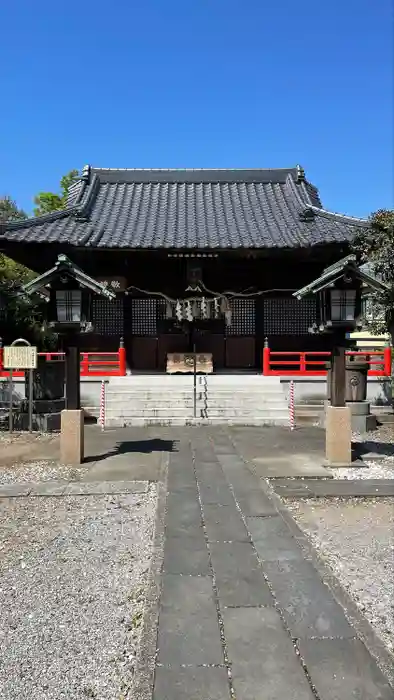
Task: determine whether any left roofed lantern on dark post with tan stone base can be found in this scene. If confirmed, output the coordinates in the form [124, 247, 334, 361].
[23, 255, 116, 463]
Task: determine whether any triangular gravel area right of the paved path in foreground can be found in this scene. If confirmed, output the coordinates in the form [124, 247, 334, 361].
[286, 498, 394, 663]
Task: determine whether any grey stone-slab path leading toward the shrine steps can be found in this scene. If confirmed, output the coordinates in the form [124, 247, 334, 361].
[153, 431, 394, 700]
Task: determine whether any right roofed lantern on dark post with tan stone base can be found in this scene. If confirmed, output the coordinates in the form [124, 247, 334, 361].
[293, 255, 390, 466]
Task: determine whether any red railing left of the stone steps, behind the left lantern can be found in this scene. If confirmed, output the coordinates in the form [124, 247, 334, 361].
[0, 345, 126, 377]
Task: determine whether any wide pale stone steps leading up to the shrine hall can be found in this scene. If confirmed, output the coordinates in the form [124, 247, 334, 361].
[101, 374, 289, 427]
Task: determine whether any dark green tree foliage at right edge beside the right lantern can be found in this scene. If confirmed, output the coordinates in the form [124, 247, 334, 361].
[354, 209, 394, 343]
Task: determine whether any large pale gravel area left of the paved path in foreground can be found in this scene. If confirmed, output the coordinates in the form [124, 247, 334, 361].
[0, 486, 156, 700]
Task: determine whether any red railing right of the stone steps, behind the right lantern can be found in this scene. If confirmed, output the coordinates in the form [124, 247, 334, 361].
[263, 347, 392, 377]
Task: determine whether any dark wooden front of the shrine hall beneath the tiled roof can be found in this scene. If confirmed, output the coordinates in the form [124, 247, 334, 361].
[63, 248, 338, 371]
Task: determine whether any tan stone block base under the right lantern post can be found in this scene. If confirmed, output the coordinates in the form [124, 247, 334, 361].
[326, 406, 352, 467]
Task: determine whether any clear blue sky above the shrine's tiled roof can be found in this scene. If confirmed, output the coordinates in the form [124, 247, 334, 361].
[0, 0, 393, 216]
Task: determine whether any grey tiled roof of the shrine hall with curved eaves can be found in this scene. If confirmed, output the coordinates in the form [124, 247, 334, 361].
[0, 166, 368, 250]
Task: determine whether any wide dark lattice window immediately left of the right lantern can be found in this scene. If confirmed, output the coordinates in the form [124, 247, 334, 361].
[264, 298, 316, 336]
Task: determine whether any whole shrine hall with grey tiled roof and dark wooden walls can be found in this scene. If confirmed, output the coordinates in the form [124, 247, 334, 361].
[0, 166, 368, 372]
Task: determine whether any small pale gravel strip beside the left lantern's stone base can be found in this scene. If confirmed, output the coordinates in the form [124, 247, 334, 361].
[0, 460, 87, 485]
